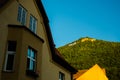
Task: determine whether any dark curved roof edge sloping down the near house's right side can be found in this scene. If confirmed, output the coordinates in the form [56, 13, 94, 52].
[36, 0, 77, 73]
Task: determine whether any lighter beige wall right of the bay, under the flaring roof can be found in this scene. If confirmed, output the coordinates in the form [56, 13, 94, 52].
[41, 43, 71, 80]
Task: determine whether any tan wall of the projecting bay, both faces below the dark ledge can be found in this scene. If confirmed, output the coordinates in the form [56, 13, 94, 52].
[2, 27, 43, 80]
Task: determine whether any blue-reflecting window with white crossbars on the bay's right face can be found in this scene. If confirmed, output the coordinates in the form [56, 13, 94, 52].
[27, 48, 36, 72]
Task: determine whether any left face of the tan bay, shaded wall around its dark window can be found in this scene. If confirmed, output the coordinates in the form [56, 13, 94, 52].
[2, 26, 22, 80]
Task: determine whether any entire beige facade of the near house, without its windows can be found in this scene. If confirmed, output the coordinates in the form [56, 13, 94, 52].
[0, 0, 77, 80]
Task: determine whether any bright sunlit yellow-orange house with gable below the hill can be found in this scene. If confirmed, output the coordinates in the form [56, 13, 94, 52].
[74, 64, 108, 80]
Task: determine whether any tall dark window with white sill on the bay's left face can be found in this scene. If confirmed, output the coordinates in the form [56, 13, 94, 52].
[4, 41, 16, 71]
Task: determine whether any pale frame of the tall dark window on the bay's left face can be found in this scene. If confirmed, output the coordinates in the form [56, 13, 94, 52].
[3, 41, 16, 72]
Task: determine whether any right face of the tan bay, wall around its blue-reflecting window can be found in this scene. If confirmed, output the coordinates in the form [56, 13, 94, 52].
[18, 27, 44, 80]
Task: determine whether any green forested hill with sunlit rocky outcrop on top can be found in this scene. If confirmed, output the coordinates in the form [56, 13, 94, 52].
[58, 37, 120, 80]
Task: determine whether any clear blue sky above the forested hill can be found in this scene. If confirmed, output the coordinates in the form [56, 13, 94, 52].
[42, 0, 120, 47]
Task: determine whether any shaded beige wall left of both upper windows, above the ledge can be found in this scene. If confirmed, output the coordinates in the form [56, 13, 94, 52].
[0, 0, 19, 25]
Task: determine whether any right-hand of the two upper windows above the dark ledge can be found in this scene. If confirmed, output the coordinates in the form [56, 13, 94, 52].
[29, 15, 37, 33]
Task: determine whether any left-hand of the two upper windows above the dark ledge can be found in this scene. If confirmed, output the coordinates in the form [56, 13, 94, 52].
[17, 5, 27, 25]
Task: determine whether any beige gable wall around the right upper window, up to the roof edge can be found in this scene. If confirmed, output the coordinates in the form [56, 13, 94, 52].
[18, 0, 44, 38]
